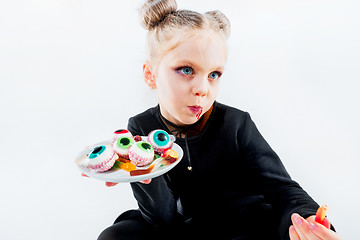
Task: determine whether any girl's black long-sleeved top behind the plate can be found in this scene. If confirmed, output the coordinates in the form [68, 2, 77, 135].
[104, 102, 318, 239]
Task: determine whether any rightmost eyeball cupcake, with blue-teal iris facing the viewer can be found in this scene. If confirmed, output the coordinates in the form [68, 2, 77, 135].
[148, 129, 175, 155]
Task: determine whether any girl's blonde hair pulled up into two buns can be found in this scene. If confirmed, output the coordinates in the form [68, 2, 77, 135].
[140, 0, 230, 61]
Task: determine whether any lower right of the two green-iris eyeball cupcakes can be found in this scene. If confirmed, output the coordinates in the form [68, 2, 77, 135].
[129, 141, 154, 167]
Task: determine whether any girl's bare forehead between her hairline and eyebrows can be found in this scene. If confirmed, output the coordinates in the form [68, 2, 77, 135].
[163, 31, 227, 68]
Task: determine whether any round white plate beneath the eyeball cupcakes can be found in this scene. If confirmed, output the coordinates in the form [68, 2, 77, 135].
[75, 137, 184, 183]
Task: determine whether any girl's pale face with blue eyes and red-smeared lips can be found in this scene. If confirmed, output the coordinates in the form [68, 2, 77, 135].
[144, 31, 226, 126]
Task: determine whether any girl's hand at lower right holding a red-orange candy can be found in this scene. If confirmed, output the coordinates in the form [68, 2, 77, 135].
[289, 213, 341, 240]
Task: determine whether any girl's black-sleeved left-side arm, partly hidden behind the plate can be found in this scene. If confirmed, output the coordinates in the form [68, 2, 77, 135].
[128, 118, 176, 226]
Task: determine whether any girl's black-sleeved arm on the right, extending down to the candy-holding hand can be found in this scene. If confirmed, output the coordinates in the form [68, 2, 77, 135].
[239, 113, 319, 239]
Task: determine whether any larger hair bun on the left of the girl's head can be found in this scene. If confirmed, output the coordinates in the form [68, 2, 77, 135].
[140, 0, 177, 30]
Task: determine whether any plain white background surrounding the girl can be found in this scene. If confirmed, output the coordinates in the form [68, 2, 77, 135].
[0, 0, 360, 240]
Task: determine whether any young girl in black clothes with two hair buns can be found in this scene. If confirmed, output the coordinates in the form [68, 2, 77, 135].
[99, 0, 340, 240]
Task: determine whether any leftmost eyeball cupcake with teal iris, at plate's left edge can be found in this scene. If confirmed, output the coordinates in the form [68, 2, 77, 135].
[87, 144, 118, 172]
